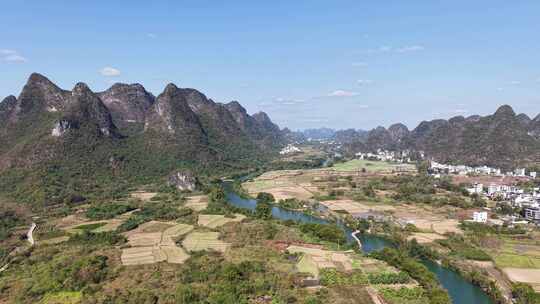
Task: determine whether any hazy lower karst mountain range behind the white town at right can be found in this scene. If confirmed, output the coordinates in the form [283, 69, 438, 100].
[336, 105, 540, 169]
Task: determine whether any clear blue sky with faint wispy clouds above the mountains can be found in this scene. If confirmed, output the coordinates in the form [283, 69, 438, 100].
[0, 0, 540, 129]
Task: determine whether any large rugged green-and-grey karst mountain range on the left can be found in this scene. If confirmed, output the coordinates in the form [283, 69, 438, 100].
[0, 74, 285, 203]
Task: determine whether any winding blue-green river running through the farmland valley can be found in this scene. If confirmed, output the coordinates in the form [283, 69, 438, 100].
[225, 182, 493, 304]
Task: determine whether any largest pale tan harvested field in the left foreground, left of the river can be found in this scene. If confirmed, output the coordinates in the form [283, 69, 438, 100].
[121, 221, 194, 265]
